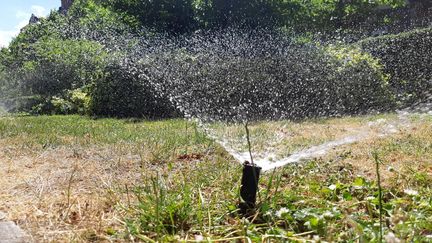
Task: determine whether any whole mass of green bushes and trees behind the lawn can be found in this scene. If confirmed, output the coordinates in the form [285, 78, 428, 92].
[0, 0, 432, 118]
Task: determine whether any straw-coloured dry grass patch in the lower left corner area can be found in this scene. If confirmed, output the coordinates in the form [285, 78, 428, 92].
[0, 142, 153, 242]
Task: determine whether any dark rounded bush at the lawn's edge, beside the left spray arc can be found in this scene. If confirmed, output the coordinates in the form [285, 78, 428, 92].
[90, 59, 175, 119]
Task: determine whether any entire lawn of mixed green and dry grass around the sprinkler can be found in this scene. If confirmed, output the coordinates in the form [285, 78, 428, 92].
[0, 114, 432, 242]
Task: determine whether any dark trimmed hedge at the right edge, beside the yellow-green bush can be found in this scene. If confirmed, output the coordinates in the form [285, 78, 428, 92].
[356, 28, 432, 104]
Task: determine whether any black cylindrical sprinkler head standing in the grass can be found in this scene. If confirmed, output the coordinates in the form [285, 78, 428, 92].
[239, 161, 261, 214]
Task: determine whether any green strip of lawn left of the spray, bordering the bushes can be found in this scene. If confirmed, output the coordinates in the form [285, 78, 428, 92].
[0, 116, 205, 145]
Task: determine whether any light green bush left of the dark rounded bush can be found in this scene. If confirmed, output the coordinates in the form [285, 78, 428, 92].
[2, 38, 107, 114]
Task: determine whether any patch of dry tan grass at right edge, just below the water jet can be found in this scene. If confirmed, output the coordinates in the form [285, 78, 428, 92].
[324, 119, 432, 185]
